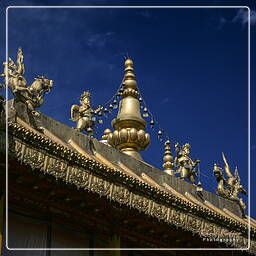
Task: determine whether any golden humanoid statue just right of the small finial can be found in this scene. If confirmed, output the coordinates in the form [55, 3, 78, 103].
[174, 143, 200, 184]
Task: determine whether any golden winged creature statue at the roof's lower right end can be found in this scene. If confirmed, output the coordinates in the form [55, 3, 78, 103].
[213, 153, 246, 210]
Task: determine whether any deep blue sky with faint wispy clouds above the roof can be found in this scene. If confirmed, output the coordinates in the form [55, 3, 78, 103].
[0, 1, 256, 217]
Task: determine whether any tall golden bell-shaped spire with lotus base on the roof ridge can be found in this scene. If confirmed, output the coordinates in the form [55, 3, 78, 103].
[108, 59, 150, 160]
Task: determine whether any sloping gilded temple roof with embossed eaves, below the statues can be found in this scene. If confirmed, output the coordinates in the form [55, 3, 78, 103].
[2, 101, 256, 251]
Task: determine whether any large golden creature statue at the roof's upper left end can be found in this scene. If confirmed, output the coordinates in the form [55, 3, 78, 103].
[1, 48, 53, 115]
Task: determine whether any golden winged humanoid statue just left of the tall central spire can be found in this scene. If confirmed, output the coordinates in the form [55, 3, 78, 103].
[70, 92, 102, 136]
